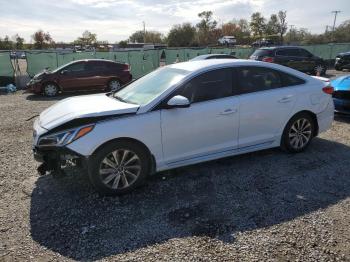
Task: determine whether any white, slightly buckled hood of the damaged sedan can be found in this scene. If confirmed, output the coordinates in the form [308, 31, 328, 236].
[39, 94, 139, 130]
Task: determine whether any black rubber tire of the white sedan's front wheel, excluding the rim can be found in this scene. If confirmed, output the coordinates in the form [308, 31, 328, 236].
[89, 141, 150, 196]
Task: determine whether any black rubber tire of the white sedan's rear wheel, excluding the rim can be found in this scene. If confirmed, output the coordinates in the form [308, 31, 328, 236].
[281, 113, 315, 153]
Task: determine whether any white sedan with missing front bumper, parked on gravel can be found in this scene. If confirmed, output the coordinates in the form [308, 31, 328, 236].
[34, 59, 334, 195]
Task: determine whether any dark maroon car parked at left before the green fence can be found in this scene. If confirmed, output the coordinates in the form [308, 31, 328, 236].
[27, 59, 132, 96]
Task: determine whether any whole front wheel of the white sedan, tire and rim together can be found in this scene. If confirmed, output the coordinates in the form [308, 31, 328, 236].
[89, 141, 150, 196]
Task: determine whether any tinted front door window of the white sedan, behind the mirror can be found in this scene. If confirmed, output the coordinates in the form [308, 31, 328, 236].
[178, 68, 232, 103]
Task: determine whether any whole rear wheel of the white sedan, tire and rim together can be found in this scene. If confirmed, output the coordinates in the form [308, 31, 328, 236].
[281, 113, 315, 153]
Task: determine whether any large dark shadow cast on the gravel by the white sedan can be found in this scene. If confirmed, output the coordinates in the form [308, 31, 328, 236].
[30, 138, 350, 260]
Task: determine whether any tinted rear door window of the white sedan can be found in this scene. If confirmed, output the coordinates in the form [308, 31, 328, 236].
[237, 67, 283, 94]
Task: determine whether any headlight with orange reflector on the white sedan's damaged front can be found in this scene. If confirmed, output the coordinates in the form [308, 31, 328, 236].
[38, 124, 95, 146]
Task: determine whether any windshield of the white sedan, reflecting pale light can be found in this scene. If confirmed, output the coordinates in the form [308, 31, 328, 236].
[114, 67, 189, 105]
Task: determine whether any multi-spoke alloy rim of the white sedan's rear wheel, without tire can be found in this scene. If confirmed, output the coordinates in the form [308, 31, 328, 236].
[289, 118, 312, 149]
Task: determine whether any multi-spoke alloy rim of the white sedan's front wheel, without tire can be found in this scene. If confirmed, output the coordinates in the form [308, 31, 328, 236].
[99, 149, 141, 189]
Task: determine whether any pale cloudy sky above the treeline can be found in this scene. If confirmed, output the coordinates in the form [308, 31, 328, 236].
[0, 0, 350, 43]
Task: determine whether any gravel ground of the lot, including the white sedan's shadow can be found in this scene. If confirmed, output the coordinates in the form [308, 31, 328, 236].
[0, 70, 350, 261]
